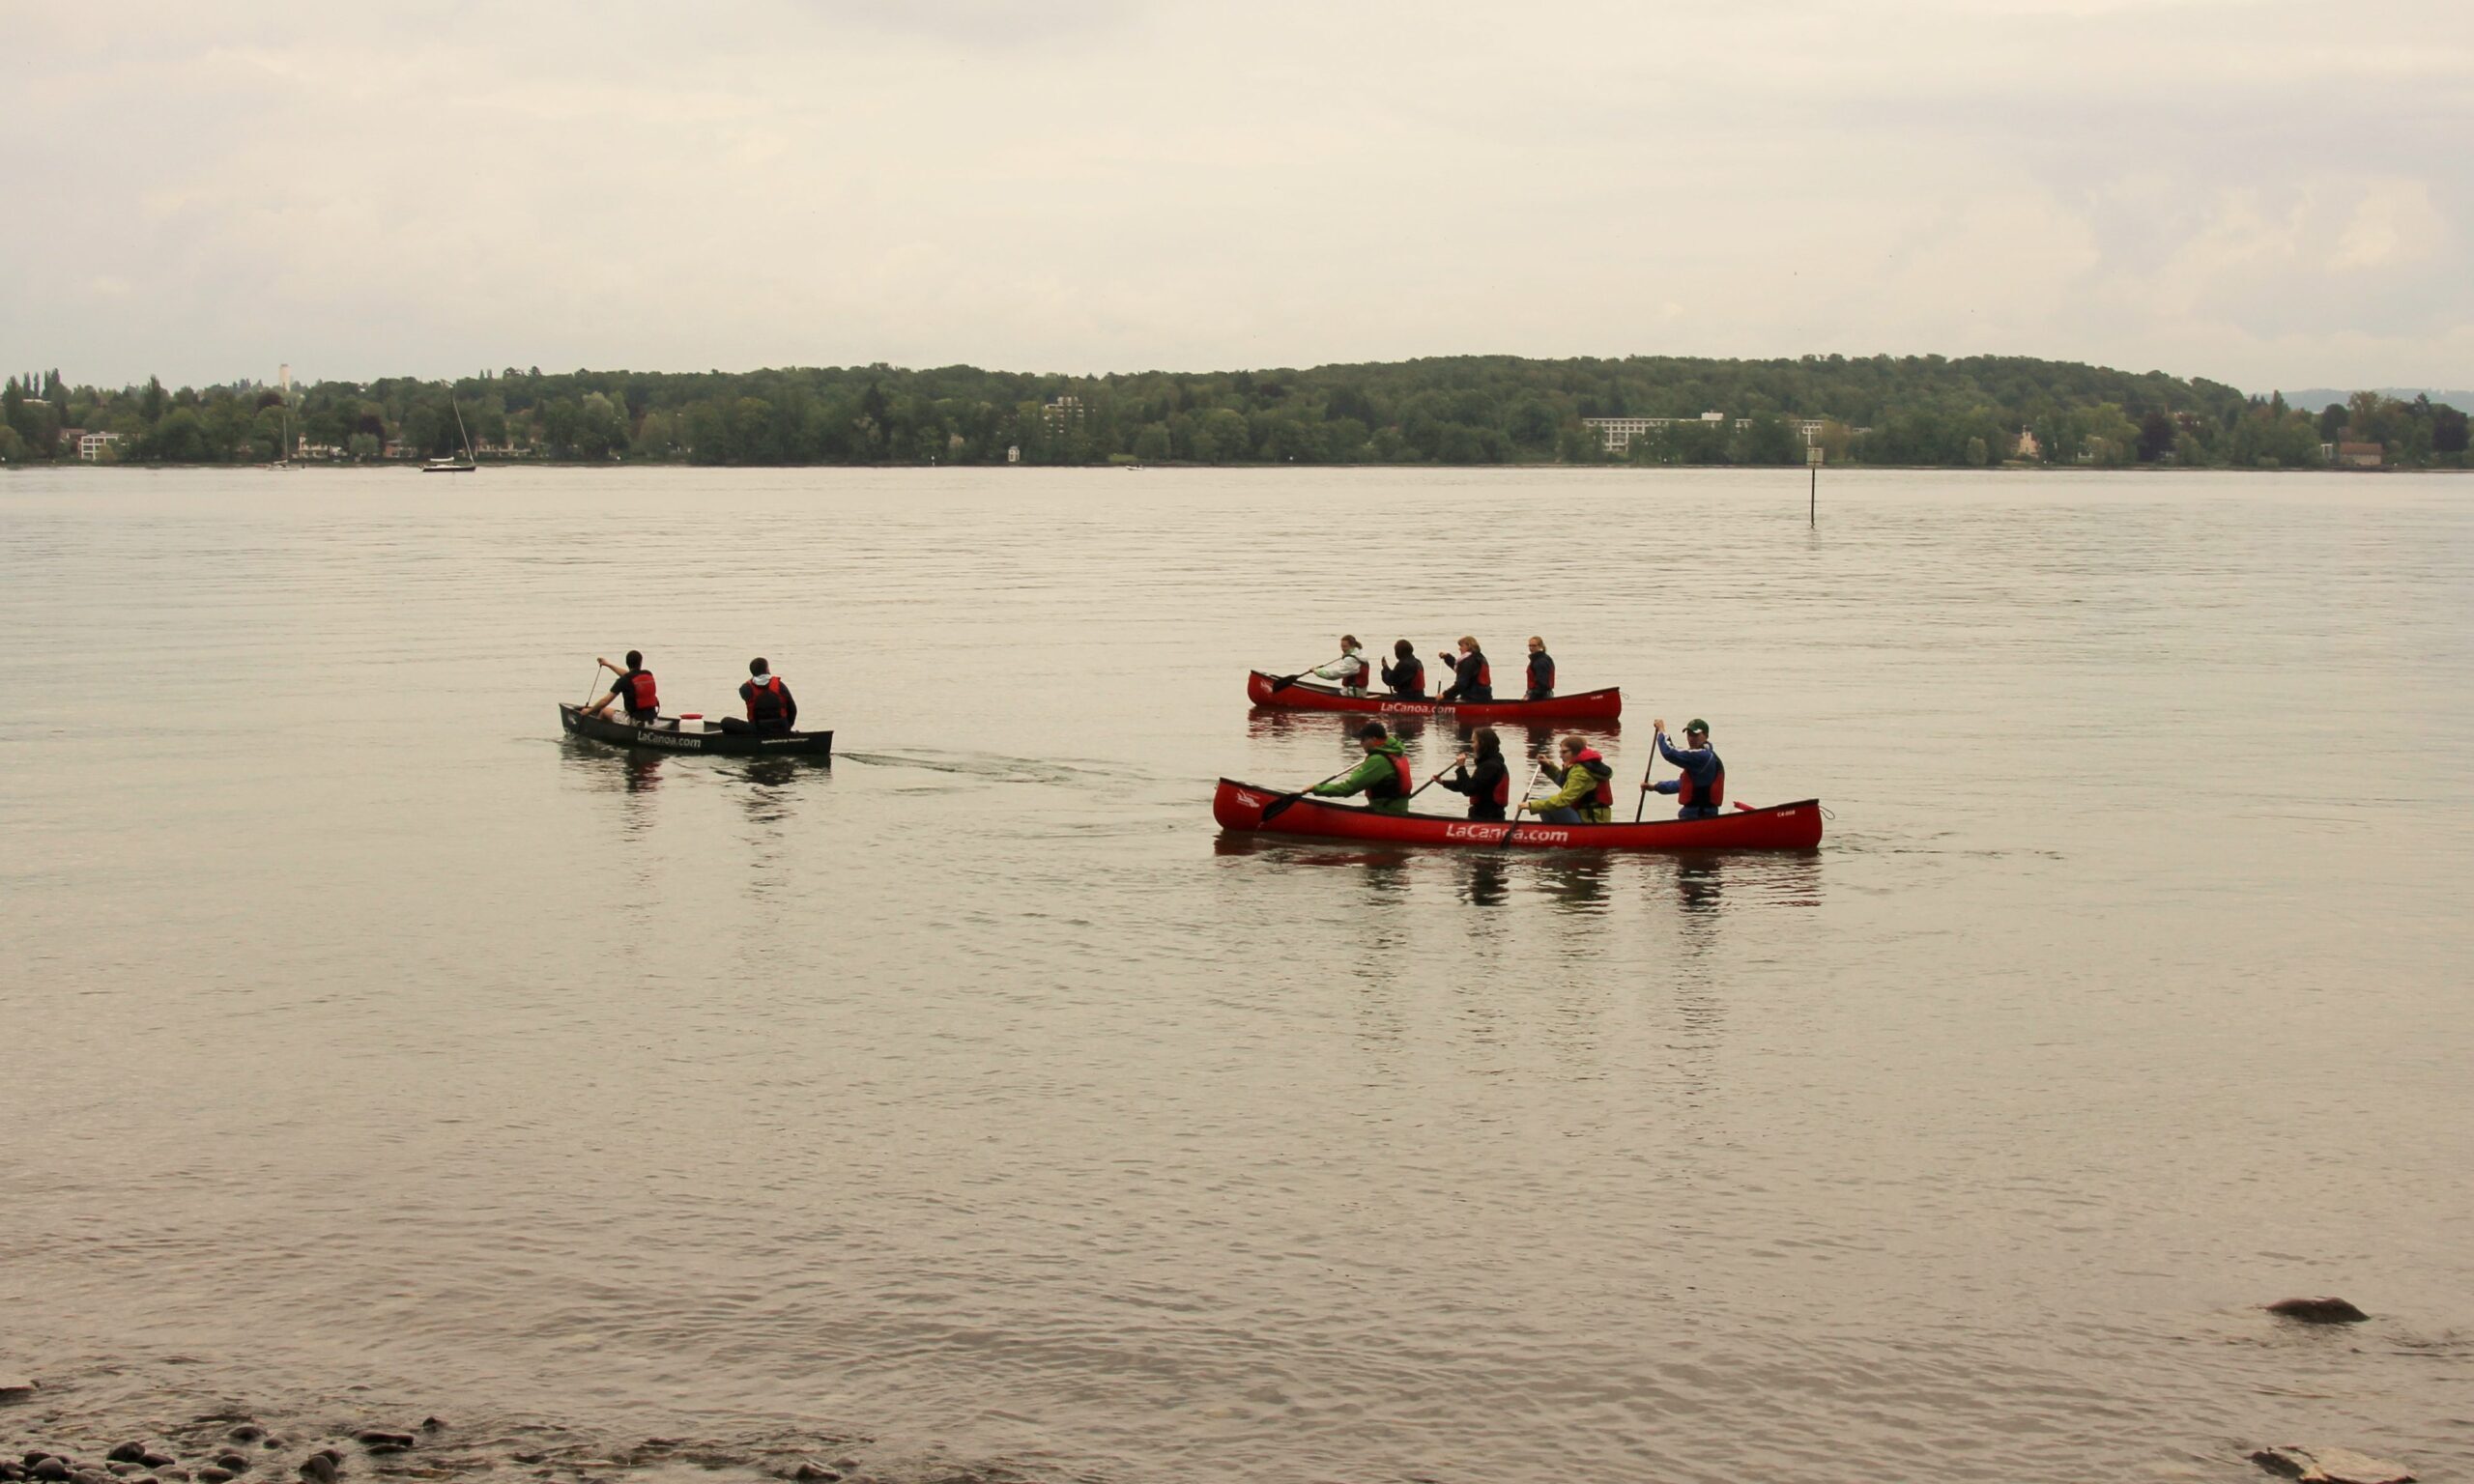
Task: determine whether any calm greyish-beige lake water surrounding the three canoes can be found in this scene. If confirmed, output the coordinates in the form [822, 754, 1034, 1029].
[0, 470, 2474, 1484]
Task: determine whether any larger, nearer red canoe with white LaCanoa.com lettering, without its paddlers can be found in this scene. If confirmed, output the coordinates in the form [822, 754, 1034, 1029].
[1212, 779, 1821, 851]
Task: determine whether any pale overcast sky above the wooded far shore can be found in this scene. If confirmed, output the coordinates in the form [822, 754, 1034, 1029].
[0, 0, 2474, 390]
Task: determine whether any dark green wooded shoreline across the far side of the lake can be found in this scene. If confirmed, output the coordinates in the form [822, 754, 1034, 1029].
[0, 357, 2469, 468]
